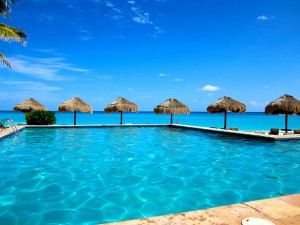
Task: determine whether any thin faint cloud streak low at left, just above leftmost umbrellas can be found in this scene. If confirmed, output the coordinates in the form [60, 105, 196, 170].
[1, 81, 62, 91]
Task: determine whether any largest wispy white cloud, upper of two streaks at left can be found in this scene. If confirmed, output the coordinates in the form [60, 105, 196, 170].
[9, 56, 88, 81]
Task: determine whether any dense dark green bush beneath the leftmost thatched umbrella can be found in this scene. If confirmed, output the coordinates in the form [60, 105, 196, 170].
[25, 110, 56, 125]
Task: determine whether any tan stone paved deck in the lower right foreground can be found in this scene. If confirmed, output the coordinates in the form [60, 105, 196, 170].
[100, 194, 300, 225]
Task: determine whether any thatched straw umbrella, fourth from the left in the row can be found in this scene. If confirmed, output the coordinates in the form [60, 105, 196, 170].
[153, 98, 191, 124]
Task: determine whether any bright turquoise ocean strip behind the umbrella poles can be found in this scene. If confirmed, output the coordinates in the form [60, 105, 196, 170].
[0, 111, 300, 131]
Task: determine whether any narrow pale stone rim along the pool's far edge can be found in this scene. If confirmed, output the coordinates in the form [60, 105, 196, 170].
[0, 124, 300, 141]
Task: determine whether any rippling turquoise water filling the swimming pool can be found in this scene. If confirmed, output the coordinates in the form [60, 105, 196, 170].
[0, 127, 300, 225]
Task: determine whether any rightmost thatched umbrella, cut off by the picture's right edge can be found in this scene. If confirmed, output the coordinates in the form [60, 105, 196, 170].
[265, 95, 300, 132]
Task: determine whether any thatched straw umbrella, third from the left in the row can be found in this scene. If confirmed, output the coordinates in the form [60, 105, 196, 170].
[104, 97, 139, 124]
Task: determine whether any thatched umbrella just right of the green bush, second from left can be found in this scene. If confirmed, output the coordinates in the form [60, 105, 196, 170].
[58, 97, 93, 125]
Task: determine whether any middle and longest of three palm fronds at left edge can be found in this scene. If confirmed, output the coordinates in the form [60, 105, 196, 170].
[0, 23, 27, 46]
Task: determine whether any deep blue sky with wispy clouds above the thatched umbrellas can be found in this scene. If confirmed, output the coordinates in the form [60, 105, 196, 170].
[0, 0, 300, 111]
